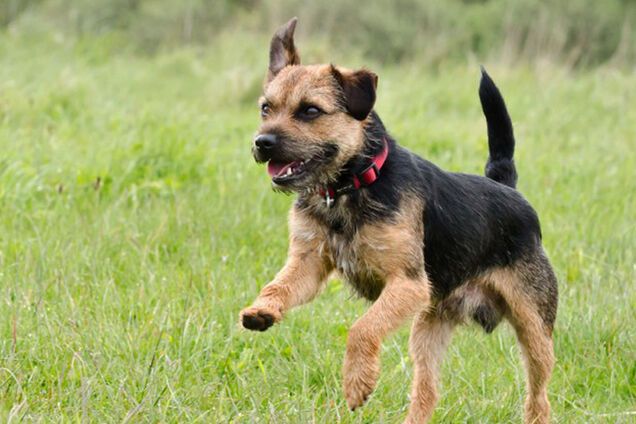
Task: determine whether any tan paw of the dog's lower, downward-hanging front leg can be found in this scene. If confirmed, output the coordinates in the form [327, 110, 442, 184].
[343, 356, 380, 411]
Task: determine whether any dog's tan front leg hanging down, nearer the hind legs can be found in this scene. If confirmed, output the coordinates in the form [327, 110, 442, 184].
[343, 275, 430, 410]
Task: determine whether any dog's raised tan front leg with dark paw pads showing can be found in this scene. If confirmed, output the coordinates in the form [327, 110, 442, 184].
[240, 213, 332, 331]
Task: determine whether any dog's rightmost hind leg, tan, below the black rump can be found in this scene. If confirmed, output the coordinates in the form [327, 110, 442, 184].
[492, 254, 557, 424]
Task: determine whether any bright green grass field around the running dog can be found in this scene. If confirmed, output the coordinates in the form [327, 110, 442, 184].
[0, 34, 636, 423]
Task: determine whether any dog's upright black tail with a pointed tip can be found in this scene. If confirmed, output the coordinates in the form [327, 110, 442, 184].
[479, 66, 517, 188]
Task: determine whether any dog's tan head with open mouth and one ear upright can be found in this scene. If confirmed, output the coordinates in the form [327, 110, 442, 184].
[253, 18, 378, 191]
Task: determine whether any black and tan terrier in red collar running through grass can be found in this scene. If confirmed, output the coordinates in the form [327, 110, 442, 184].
[239, 18, 558, 423]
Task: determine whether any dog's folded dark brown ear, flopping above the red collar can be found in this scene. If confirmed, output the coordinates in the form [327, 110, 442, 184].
[332, 67, 378, 121]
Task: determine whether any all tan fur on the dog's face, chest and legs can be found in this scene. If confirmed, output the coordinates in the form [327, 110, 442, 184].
[241, 21, 554, 423]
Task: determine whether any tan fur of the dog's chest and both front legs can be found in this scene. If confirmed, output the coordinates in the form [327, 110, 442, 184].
[241, 199, 430, 409]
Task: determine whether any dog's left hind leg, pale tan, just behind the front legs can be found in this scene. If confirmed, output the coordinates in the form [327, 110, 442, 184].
[405, 311, 455, 424]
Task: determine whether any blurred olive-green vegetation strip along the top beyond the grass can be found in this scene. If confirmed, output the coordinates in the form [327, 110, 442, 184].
[0, 0, 636, 68]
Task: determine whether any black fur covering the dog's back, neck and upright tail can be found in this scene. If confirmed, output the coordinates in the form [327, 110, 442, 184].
[297, 70, 541, 324]
